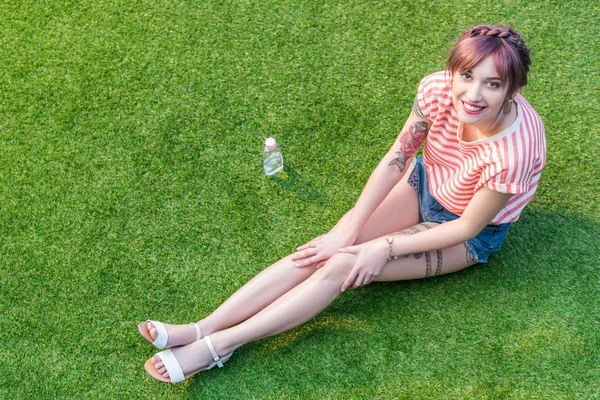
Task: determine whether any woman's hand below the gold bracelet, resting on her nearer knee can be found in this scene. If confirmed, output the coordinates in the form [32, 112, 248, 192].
[340, 238, 389, 292]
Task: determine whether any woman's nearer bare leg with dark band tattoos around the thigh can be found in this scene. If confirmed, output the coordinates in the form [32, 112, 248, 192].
[152, 231, 474, 377]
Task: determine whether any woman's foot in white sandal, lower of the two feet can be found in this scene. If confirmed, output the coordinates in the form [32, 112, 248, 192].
[145, 338, 231, 382]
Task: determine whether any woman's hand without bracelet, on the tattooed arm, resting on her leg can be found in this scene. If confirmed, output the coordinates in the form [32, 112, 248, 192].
[292, 226, 356, 268]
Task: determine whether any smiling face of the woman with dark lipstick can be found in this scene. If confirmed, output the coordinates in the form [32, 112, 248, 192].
[452, 56, 508, 132]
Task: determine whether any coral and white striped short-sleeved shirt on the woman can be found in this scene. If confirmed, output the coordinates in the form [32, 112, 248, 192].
[417, 71, 546, 224]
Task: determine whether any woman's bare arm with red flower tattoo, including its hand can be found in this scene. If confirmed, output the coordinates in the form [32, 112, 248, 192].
[292, 101, 430, 267]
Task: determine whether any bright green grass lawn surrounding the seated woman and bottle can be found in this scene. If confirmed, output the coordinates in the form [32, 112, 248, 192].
[0, 0, 600, 399]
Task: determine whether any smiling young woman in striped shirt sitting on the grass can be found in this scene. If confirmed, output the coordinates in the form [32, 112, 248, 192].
[138, 25, 545, 382]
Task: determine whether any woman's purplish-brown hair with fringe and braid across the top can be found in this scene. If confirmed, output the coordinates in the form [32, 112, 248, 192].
[446, 24, 531, 111]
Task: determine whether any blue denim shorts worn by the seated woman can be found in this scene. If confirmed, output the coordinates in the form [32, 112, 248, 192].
[408, 156, 511, 263]
